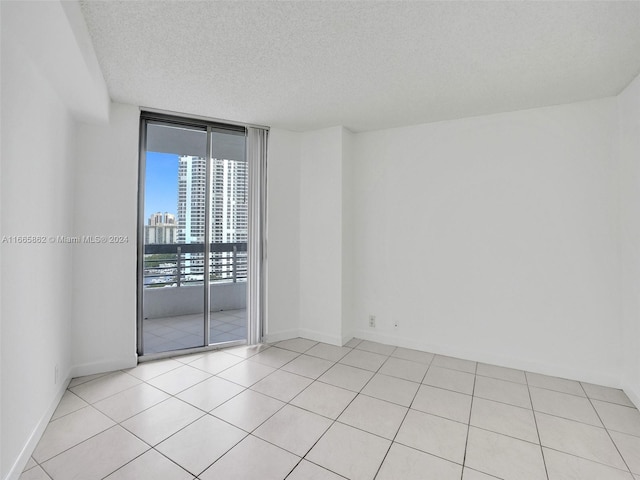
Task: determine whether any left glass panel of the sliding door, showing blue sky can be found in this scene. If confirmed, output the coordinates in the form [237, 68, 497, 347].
[138, 121, 209, 355]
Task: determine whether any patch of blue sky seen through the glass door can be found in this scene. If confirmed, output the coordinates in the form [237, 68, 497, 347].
[144, 152, 178, 220]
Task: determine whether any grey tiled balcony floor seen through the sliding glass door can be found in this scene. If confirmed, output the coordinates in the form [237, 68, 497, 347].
[143, 309, 247, 355]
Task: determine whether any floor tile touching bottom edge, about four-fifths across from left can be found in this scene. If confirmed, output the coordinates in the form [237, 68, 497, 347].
[465, 427, 547, 480]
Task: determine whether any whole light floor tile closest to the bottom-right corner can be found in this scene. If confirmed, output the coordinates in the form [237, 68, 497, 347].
[535, 412, 625, 468]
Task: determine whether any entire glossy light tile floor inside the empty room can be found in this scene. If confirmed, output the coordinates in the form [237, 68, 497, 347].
[21, 338, 640, 480]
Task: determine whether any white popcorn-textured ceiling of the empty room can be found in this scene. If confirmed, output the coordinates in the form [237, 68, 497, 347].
[81, 0, 640, 131]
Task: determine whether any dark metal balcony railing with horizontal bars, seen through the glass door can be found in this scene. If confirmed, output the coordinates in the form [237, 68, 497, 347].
[144, 242, 247, 288]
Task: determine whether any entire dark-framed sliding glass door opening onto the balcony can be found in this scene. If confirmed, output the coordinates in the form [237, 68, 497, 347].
[138, 114, 261, 355]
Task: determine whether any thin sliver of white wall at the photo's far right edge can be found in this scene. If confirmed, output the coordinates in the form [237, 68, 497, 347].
[618, 77, 640, 406]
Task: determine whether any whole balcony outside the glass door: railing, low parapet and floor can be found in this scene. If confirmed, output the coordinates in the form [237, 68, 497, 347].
[143, 242, 247, 354]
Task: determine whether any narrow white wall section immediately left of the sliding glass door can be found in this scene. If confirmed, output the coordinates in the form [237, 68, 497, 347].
[72, 103, 140, 376]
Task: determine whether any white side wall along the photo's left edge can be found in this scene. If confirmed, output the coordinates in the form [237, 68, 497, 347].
[0, 31, 75, 478]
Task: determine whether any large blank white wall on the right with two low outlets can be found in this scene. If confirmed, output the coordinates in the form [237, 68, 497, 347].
[354, 98, 622, 384]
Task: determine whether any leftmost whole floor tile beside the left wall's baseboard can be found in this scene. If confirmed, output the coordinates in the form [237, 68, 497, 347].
[33, 406, 115, 463]
